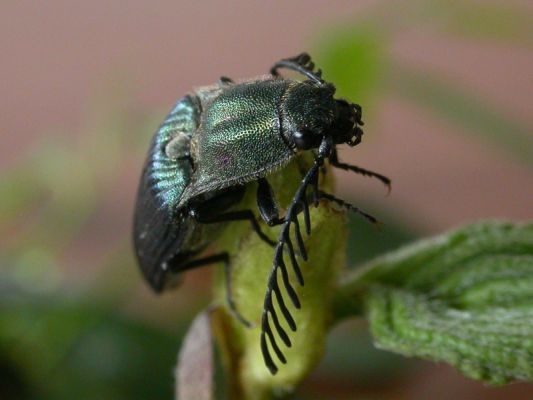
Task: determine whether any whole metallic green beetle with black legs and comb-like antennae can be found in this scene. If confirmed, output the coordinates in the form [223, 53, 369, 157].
[133, 53, 390, 374]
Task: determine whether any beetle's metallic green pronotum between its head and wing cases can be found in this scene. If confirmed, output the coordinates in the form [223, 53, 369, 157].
[180, 79, 295, 206]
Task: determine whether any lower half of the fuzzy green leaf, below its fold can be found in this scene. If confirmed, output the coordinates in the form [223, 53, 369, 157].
[368, 288, 533, 384]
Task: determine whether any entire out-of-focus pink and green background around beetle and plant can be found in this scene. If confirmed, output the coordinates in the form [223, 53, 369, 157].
[0, 0, 533, 399]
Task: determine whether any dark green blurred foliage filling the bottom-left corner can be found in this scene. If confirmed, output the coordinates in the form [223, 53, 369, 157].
[0, 288, 181, 400]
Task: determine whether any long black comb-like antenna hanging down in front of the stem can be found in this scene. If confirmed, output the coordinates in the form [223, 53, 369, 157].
[261, 137, 332, 374]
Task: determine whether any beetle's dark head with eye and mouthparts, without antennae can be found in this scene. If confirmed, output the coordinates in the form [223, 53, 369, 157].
[282, 81, 363, 150]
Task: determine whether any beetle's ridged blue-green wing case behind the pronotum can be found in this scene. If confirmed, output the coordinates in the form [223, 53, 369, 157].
[133, 95, 200, 292]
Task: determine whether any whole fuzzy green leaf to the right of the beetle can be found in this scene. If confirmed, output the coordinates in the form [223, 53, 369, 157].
[337, 223, 533, 384]
